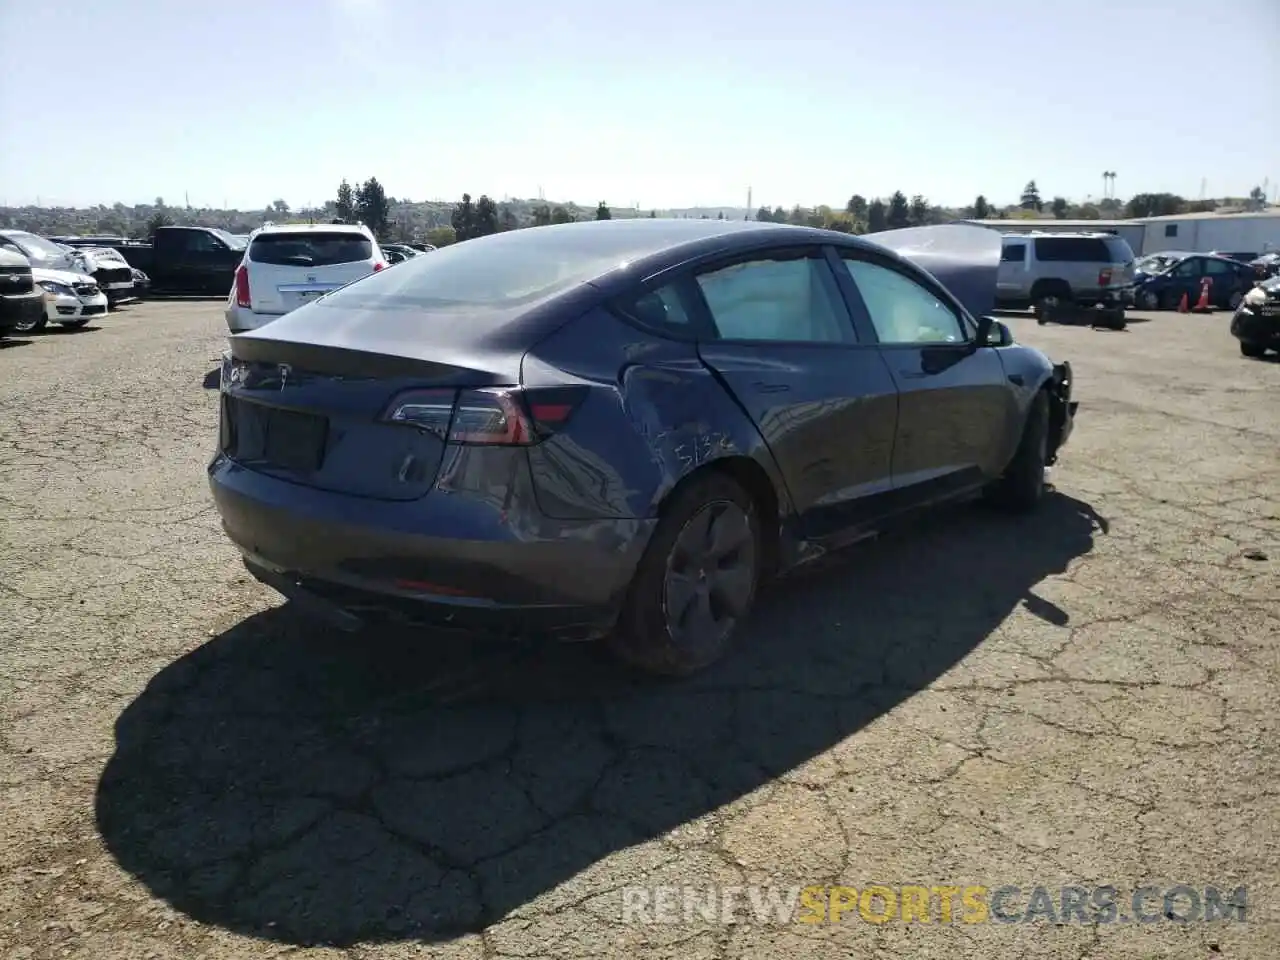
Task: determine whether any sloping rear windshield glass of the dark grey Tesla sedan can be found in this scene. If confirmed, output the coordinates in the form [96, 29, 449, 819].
[308, 224, 671, 310]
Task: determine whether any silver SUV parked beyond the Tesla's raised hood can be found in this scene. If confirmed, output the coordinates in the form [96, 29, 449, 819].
[996, 233, 1134, 319]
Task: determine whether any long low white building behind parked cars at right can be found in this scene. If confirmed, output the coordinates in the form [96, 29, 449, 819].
[960, 207, 1280, 256]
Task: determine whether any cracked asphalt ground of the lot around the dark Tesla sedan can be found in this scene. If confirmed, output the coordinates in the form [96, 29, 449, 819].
[0, 302, 1280, 960]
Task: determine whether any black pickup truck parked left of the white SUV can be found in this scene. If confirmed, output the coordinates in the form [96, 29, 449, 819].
[104, 227, 246, 297]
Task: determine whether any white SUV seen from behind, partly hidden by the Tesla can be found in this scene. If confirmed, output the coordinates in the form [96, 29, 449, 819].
[227, 224, 387, 334]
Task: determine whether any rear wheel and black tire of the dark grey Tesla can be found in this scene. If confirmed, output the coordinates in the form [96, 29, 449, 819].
[609, 472, 762, 676]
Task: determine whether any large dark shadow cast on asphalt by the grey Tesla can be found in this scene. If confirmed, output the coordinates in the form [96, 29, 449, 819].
[96, 493, 1107, 946]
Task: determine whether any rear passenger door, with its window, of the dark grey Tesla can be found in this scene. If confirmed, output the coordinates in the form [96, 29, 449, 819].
[689, 246, 897, 543]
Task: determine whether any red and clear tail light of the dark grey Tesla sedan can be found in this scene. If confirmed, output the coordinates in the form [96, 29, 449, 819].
[381, 387, 586, 447]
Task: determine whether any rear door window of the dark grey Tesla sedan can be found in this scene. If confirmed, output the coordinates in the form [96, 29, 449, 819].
[696, 256, 855, 343]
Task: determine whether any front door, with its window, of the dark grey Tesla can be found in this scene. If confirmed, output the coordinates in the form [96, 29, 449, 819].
[841, 248, 1016, 503]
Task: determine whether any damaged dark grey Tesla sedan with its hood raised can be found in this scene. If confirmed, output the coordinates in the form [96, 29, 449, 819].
[209, 218, 1076, 673]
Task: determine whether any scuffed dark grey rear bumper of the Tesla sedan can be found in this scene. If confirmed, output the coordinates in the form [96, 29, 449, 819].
[209, 454, 657, 639]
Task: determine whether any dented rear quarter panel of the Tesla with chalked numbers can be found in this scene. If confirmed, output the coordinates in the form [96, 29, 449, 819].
[521, 308, 790, 520]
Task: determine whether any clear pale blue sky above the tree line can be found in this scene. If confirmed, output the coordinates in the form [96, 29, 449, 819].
[0, 0, 1280, 209]
